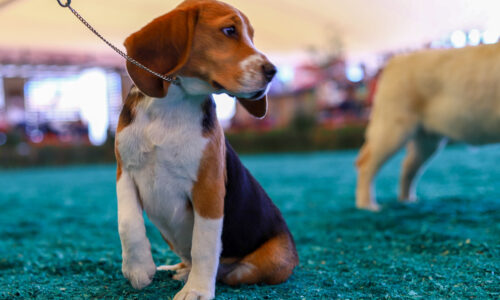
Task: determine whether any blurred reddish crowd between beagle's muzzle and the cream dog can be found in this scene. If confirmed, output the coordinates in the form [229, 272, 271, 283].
[229, 58, 381, 130]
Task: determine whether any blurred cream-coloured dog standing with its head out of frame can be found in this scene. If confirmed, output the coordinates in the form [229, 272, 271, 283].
[356, 44, 500, 210]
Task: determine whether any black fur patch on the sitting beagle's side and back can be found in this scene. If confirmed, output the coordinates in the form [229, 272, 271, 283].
[221, 139, 290, 257]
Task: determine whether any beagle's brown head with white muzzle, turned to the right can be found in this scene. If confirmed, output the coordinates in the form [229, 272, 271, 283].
[125, 0, 276, 118]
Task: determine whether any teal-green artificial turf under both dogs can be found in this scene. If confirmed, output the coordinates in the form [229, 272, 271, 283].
[0, 146, 500, 299]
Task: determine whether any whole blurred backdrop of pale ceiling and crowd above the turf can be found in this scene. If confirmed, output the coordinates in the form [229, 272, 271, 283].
[0, 0, 500, 166]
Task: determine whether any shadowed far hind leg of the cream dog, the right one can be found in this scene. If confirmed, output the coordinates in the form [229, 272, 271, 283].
[399, 129, 446, 203]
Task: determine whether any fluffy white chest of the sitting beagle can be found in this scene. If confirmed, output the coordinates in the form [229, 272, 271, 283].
[118, 88, 207, 256]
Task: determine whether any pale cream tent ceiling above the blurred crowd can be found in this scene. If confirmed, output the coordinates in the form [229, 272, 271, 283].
[0, 0, 500, 62]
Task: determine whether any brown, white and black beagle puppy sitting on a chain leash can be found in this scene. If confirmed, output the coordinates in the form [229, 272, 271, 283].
[115, 0, 298, 300]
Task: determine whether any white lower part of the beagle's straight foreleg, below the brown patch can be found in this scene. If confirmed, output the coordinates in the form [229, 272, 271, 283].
[174, 212, 223, 300]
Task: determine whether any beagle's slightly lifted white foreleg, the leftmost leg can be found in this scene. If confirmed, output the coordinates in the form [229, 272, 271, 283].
[116, 170, 156, 289]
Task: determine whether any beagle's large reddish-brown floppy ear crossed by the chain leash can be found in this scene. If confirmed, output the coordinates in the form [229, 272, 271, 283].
[124, 8, 198, 98]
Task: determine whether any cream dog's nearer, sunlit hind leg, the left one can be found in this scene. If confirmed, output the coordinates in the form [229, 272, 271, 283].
[356, 117, 417, 211]
